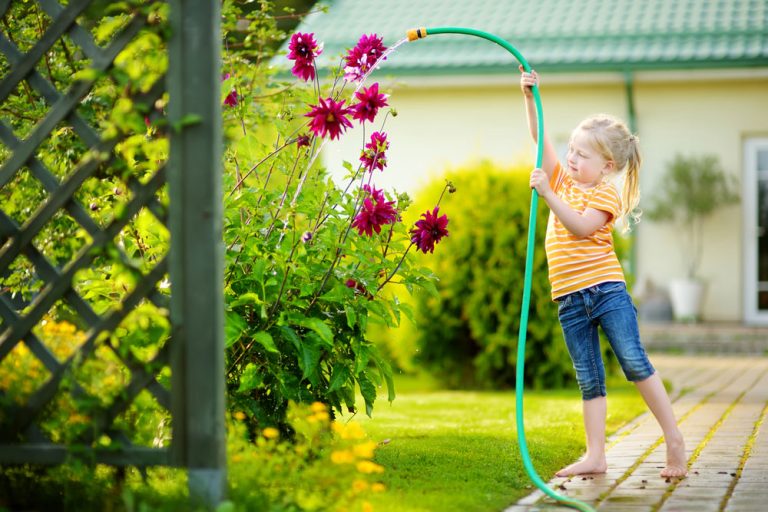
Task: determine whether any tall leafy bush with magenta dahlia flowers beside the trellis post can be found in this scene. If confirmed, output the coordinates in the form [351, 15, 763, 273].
[222, 20, 448, 434]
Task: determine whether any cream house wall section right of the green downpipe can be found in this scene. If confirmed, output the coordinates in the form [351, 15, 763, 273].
[636, 80, 768, 321]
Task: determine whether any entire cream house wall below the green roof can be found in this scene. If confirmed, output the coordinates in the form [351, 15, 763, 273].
[324, 73, 768, 321]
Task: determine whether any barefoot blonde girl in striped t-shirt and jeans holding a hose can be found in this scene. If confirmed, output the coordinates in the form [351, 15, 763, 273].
[520, 69, 687, 477]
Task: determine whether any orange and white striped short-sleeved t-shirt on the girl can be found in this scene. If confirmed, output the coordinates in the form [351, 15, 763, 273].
[546, 164, 625, 299]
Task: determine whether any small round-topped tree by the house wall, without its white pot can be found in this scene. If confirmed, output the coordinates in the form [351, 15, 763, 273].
[646, 155, 739, 280]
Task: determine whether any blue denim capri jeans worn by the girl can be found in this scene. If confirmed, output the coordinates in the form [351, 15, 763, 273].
[557, 282, 655, 400]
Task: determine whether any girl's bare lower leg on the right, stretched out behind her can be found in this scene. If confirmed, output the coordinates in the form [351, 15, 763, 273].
[635, 373, 688, 478]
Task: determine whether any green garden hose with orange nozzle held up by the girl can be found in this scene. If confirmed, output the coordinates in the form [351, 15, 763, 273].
[408, 27, 594, 512]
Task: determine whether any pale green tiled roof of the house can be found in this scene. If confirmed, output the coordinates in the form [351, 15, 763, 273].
[297, 0, 768, 75]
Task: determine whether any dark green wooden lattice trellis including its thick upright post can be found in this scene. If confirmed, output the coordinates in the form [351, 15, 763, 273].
[0, 0, 224, 501]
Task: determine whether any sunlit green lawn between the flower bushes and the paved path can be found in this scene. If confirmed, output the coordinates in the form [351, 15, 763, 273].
[358, 372, 645, 512]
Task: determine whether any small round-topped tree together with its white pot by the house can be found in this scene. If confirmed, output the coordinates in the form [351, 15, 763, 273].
[646, 155, 739, 321]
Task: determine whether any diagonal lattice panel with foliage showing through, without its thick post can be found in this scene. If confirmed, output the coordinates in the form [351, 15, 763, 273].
[0, 0, 171, 464]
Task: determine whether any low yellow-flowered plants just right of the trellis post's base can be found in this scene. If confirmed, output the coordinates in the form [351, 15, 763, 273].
[227, 402, 385, 512]
